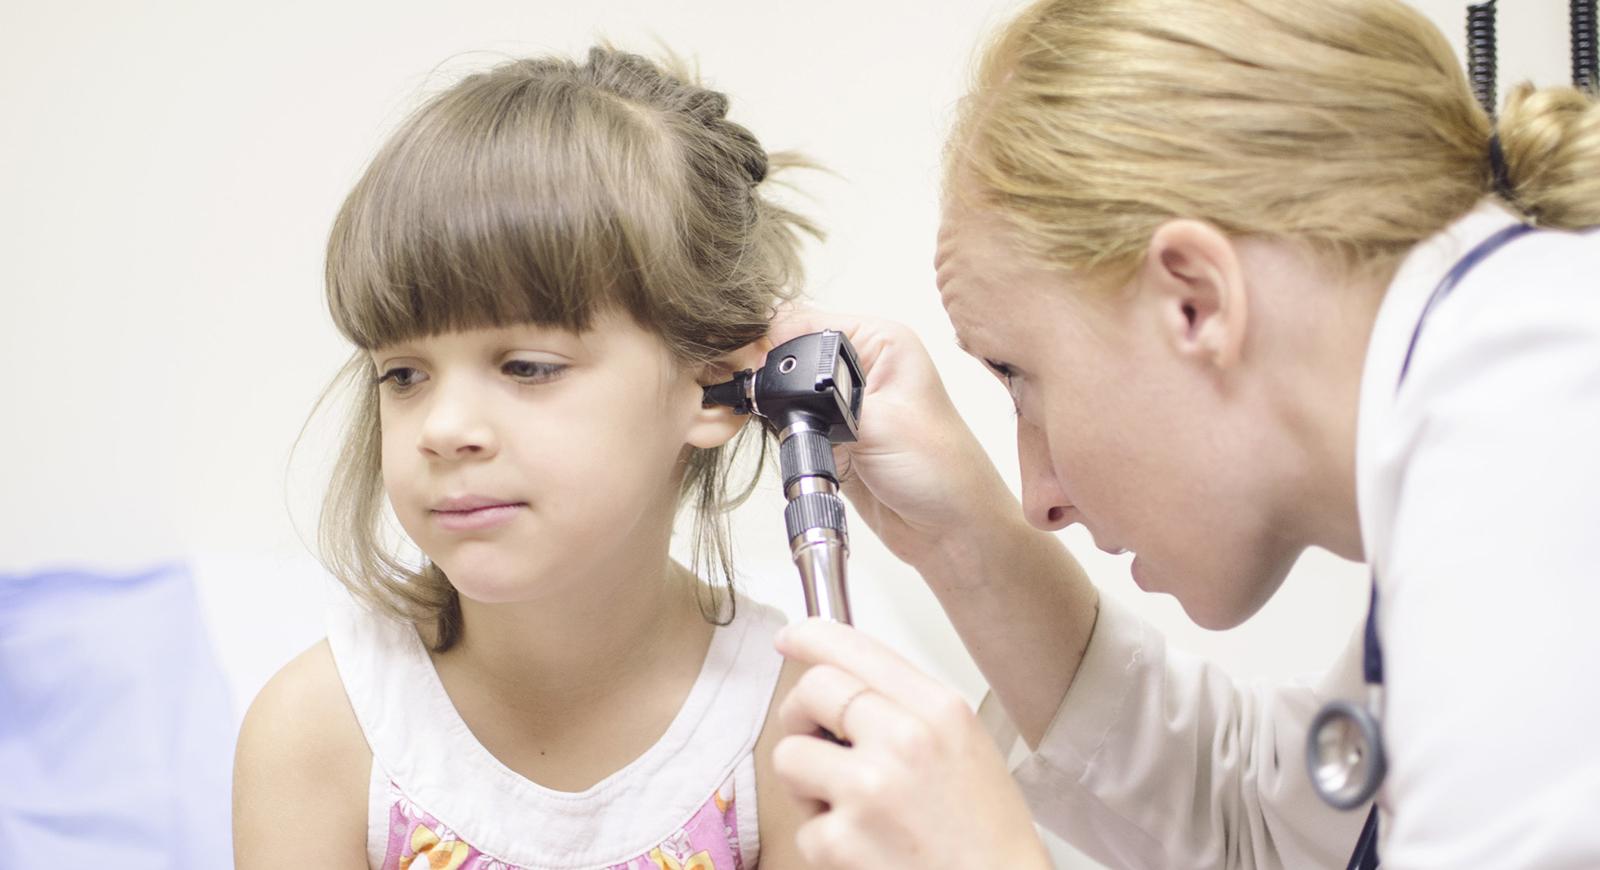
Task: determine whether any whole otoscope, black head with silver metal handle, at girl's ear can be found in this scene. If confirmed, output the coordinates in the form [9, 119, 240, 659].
[704, 329, 862, 625]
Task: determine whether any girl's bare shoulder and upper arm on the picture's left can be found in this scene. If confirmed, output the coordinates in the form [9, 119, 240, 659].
[234, 641, 371, 870]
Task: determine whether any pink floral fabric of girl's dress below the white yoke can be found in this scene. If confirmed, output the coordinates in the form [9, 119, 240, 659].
[382, 776, 744, 870]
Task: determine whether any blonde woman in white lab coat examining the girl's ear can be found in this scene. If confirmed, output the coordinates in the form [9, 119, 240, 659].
[774, 0, 1600, 868]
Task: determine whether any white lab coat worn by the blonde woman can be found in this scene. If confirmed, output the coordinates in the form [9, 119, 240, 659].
[986, 206, 1600, 868]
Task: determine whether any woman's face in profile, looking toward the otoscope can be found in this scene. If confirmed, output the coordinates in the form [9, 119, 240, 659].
[938, 208, 1304, 629]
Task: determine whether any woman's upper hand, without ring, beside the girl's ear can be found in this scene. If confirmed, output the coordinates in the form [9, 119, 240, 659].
[770, 309, 1022, 571]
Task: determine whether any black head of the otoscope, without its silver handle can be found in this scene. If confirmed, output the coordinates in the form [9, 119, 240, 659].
[706, 329, 862, 445]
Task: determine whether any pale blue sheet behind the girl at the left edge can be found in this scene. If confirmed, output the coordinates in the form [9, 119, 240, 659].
[0, 565, 235, 870]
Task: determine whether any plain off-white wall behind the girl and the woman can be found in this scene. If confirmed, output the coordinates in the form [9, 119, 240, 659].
[0, 0, 1566, 860]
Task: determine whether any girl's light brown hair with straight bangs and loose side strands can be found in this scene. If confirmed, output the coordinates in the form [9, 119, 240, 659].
[318, 48, 819, 649]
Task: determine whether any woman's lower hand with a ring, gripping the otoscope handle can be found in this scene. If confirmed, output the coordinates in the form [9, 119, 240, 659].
[773, 619, 1051, 870]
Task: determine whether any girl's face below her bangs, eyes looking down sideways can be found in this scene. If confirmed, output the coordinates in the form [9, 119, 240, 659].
[371, 313, 742, 603]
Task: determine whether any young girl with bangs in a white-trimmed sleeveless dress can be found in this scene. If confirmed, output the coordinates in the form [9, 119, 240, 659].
[235, 48, 814, 870]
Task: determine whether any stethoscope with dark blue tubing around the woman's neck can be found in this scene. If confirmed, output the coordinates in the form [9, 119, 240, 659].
[1306, 224, 1533, 870]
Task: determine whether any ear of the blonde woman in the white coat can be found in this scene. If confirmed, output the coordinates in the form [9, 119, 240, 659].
[1139, 221, 1248, 368]
